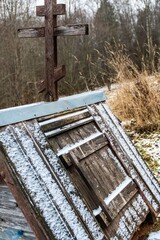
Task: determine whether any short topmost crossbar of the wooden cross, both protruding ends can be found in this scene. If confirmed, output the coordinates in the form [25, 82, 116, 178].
[36, 4, 66, 17]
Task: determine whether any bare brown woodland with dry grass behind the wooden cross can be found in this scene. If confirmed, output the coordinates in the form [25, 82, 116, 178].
[0, 0, 160, 130]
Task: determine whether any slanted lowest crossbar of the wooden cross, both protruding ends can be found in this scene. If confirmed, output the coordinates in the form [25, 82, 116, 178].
[37, 65, 66, 93]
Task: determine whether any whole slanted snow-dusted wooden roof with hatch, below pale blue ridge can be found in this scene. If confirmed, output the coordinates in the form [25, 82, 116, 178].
[0, 91, 160, 240]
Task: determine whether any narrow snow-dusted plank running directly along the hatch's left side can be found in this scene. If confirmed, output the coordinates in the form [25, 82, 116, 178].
[28, 122, 104, 240]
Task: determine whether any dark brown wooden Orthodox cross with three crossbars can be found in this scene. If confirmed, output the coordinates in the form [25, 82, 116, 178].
[18, 0, 88, 101]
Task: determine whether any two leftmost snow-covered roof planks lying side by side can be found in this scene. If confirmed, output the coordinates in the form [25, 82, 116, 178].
[0, 126, 92, 240]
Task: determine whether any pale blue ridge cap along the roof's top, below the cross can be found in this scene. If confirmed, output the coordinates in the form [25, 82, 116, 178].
[0, 91, 106, 127]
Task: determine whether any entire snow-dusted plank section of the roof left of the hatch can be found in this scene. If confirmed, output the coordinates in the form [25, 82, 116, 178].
[0, 123, 103, 240]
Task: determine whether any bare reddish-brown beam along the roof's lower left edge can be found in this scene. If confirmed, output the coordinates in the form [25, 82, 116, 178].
[0, 147, 53, 240]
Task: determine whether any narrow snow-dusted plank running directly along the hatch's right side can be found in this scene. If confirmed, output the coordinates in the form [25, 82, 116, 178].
[88, 105, 159, 215]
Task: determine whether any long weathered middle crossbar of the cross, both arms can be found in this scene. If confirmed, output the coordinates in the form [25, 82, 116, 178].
[18, 24, 89, 38]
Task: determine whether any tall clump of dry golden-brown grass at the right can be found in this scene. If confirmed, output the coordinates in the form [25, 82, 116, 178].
[106, 42, 160, 130]
